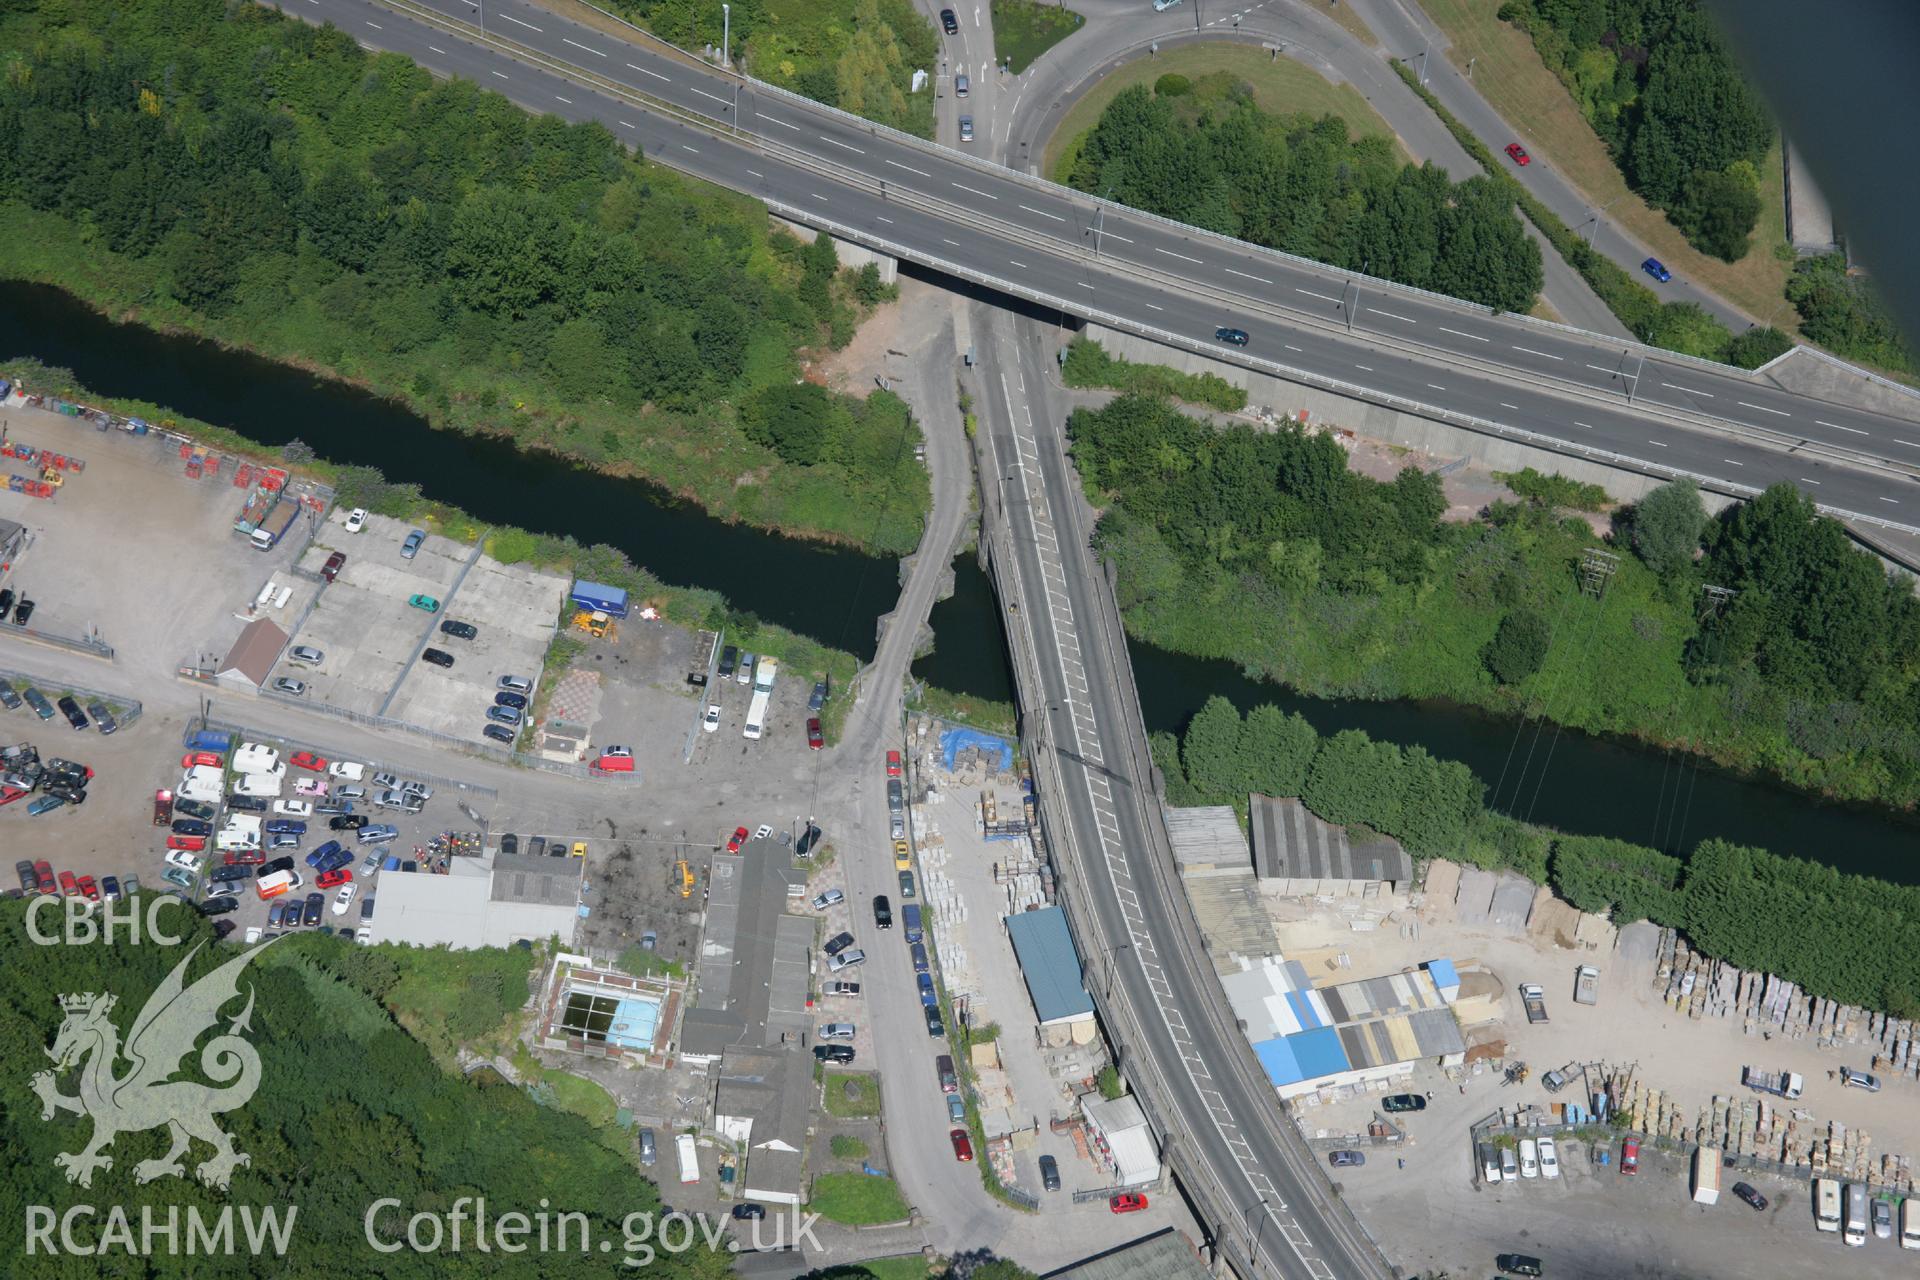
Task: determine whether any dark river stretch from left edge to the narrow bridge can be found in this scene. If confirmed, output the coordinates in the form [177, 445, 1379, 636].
[0, 280, 899, 658]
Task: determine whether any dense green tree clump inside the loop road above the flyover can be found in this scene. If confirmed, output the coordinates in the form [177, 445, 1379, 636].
[1068, 75, 1542, 311]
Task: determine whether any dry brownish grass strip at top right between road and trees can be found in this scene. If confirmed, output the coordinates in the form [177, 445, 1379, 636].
[1421, 0, 1797, 332]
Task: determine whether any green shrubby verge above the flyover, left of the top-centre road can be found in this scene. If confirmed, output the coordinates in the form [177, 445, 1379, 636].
[612, 0, 939, 138]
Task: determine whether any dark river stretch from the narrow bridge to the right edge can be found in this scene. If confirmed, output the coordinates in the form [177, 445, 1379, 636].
[914, 555, 1920, 885]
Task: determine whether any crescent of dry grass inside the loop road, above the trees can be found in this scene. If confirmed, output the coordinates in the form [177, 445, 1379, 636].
[1043, 44, 1407, 180]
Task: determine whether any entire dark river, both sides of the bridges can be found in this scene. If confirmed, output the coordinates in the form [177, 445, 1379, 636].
[15, 284, 1920, 883]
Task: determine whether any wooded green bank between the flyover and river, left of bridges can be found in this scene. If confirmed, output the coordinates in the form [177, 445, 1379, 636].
[0, 0, 931, 553]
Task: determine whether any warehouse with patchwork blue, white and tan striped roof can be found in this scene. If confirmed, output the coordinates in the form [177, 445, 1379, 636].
[1221, 956, 1467, 1098]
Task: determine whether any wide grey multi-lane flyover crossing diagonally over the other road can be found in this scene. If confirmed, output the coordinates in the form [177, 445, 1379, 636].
[299, 0, 1920, 532]
